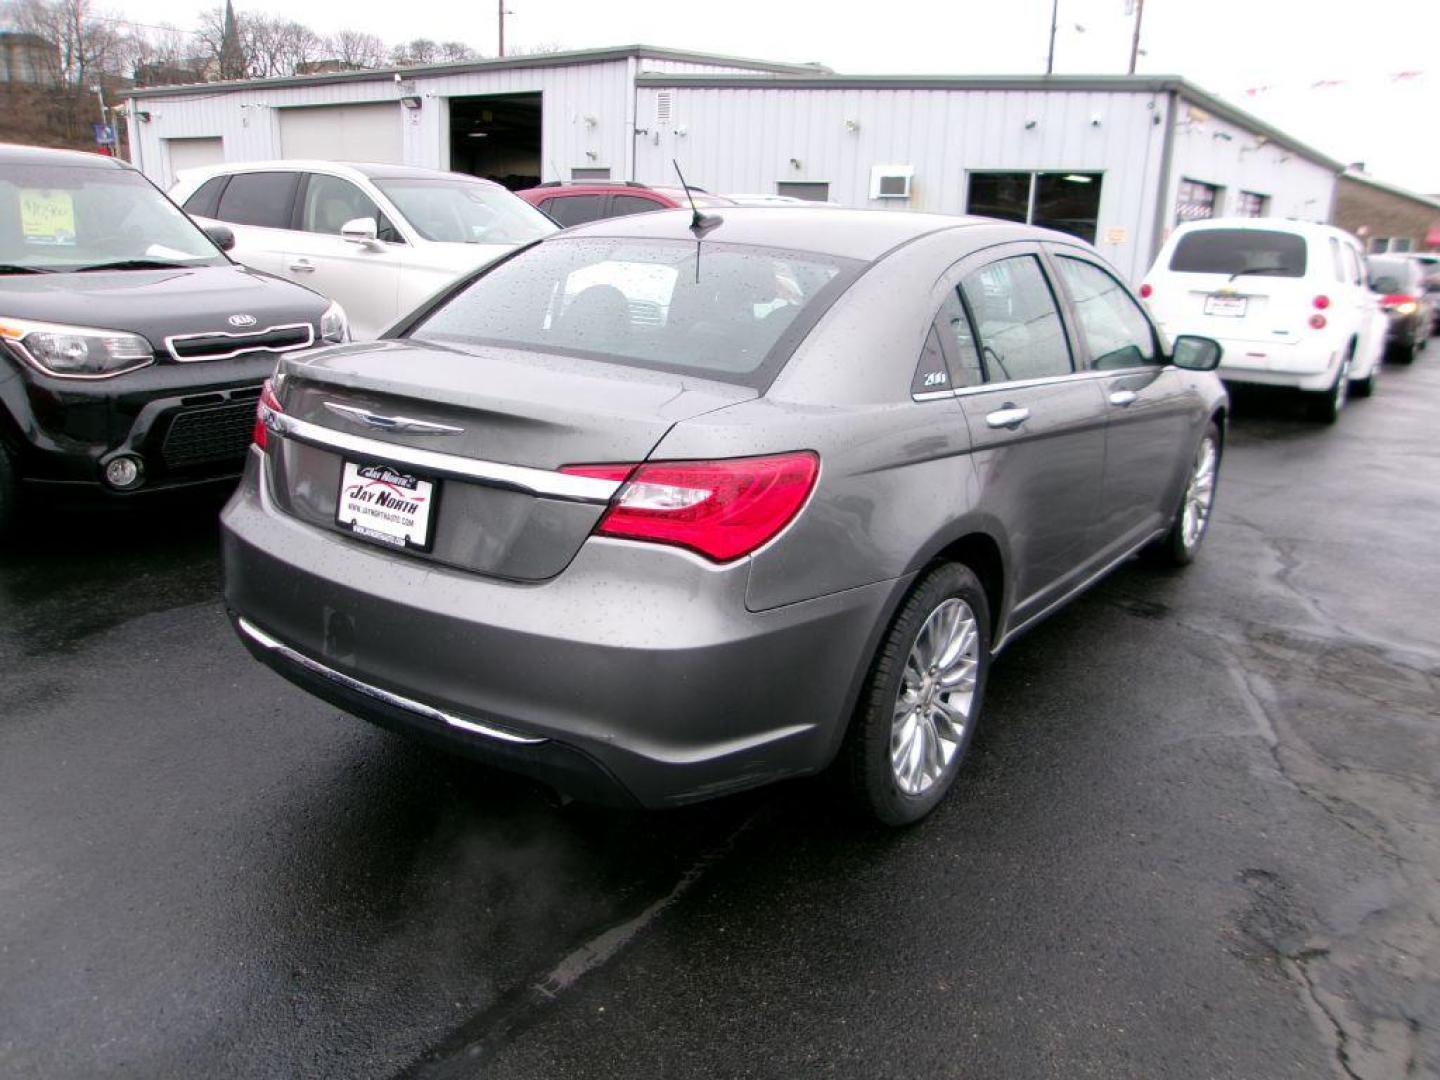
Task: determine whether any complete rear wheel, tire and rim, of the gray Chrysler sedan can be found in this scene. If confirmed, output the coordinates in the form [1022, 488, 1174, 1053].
[837, 563, 991, 825]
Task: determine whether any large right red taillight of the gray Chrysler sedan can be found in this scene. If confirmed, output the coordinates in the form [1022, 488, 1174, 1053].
[560, 451, 819, 563]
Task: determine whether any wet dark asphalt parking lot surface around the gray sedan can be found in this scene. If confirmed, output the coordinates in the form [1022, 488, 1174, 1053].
[0, 357, 1440, 1079]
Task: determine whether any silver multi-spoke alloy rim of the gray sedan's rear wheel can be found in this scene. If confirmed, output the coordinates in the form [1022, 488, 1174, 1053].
[890, 596, 981, 795]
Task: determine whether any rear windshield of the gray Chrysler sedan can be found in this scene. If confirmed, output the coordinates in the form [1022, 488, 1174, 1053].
[409, 238, 861, 387]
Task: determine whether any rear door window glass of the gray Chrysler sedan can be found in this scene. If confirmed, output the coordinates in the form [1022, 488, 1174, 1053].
[960, 255, 1074, 383]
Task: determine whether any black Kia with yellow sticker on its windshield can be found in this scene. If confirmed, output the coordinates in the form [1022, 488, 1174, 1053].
[0, 144, 347, 534]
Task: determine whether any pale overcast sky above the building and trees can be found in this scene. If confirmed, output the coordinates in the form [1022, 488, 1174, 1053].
[115, 0, 1440, 193]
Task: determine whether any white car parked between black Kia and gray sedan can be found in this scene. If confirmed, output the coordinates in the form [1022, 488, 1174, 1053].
[170, 161, 557, 338]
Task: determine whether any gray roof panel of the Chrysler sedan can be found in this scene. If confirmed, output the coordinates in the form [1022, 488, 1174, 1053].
[546, 206, 996, 262]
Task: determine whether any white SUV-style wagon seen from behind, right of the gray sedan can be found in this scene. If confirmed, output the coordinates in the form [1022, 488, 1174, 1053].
[1140, 217, 1385, 422]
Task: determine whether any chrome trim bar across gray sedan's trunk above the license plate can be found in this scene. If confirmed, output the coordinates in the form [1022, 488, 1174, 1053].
[265, 410, 621, 505]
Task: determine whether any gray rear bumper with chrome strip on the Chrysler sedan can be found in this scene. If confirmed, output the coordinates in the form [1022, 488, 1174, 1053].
[222, 456, 904, 806]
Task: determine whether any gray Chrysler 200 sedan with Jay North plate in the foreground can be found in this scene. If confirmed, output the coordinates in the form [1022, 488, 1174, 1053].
[223, 207, 1227, 824]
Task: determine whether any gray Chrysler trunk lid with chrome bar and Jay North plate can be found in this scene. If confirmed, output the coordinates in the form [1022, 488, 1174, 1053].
[268, 341, 756, 580]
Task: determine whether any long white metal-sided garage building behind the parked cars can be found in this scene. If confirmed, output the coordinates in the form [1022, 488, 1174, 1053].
[128, 46, 1342, 278]
